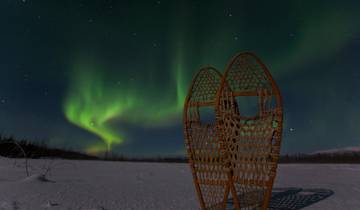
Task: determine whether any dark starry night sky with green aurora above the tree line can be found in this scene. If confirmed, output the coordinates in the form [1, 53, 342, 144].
[0, 0, 360, 156]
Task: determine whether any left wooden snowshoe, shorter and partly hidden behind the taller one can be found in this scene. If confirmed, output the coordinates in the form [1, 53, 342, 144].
[183, 66, 229, 209]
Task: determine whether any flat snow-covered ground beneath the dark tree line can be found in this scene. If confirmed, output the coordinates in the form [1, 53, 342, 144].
[0, 159, 360, 210]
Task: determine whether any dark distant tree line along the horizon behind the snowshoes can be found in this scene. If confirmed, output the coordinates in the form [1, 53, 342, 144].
[0, 135, 360, 163]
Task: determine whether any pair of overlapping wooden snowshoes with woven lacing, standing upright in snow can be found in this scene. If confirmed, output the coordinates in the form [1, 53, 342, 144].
[184, 52, 283, 210]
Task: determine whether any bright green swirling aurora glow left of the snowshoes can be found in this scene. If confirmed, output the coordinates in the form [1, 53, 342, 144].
[63, 55, 186, 153]
